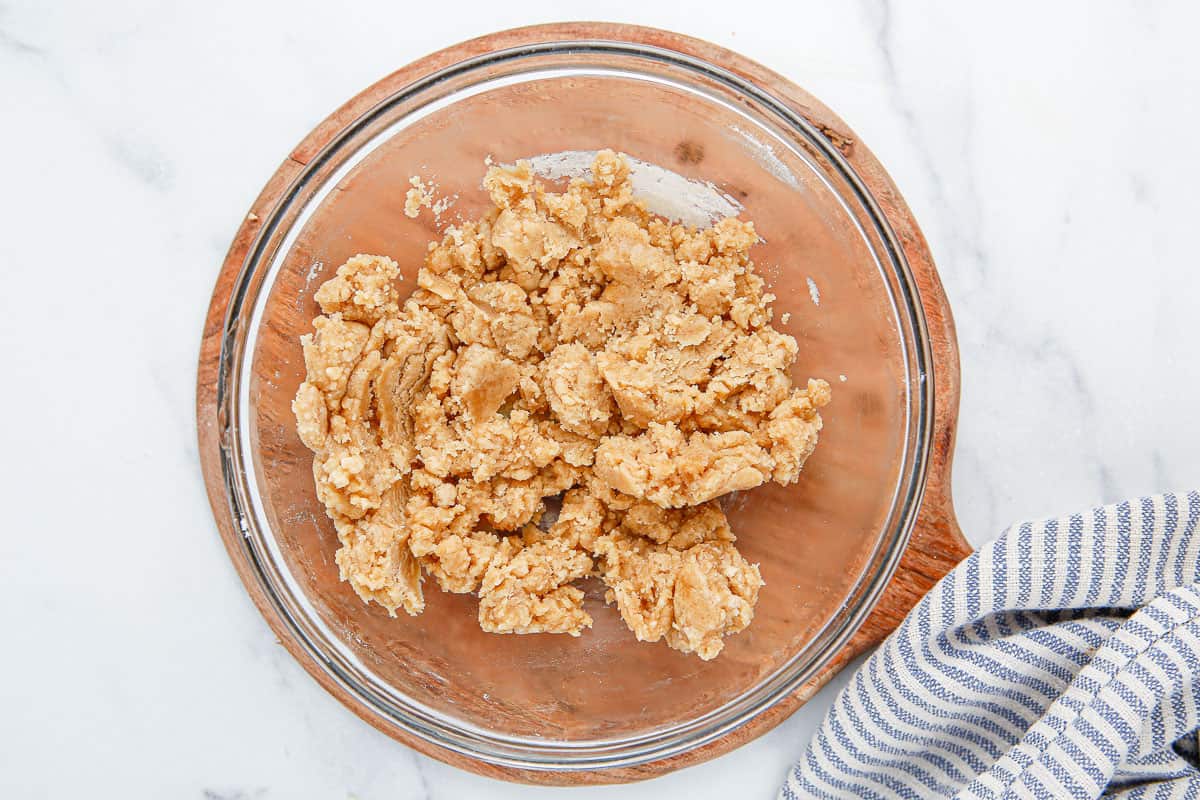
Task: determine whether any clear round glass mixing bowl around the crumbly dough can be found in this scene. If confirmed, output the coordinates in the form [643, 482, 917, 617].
[217, 31, 931, 772]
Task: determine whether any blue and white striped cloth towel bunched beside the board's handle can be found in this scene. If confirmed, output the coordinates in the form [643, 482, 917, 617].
[780, 492, 1200, 800]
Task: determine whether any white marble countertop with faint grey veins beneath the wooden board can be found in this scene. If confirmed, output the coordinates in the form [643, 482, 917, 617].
[0, 0, 1200, 800]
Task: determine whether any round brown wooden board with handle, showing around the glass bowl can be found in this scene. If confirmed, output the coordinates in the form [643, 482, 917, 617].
[197, 23, 971, 784]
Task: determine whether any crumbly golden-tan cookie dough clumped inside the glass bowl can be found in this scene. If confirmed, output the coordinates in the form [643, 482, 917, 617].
[293, 151, 829, 660]
